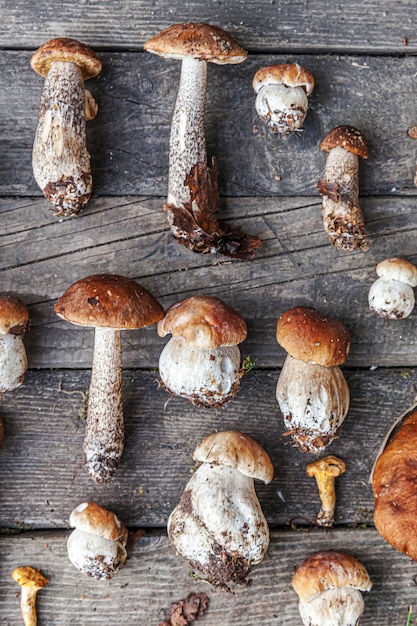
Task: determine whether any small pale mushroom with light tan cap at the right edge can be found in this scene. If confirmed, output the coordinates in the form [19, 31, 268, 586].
[368, 257, 417, 320]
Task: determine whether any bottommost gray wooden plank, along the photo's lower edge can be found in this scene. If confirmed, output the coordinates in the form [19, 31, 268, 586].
[0, 529, 417, 626]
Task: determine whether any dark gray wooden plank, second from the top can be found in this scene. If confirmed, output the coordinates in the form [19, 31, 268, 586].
[0, 51, 417, 197]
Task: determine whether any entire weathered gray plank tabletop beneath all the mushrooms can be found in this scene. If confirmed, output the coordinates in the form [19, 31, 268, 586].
[0, 0, 417, 626]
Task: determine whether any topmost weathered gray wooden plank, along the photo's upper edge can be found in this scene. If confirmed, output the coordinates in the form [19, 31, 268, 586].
[0, 0, 417, 53]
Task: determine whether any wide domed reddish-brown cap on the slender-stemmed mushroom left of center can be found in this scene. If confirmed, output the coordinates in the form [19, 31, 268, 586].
[54, 274, 164, 329]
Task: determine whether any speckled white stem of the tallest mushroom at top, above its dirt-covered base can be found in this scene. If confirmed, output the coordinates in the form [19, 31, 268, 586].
[167, 57, 207, 207]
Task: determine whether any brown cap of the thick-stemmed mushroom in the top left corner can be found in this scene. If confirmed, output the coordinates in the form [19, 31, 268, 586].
[30, 37, 102, 80]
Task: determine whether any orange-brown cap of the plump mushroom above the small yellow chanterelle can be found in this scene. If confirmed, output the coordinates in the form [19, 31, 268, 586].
[276, 306, 350, 367]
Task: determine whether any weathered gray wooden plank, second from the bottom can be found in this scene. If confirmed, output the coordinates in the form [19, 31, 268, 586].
[0, 368, 417, 528]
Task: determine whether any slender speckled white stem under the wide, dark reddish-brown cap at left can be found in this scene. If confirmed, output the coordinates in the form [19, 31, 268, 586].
[84, 328, 124, 482]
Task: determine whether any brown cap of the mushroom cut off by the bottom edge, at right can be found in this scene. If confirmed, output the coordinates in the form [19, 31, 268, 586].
[292, 552, 372, 602]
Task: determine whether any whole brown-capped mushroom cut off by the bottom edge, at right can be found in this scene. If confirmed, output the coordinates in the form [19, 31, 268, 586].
[292, 552, 372, 626]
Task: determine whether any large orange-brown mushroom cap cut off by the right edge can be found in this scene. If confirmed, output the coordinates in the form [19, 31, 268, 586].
[372, 411, 417, 561]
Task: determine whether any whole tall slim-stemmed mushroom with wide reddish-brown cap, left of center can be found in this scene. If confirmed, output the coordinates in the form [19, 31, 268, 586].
[54, 274, 164, 482]
